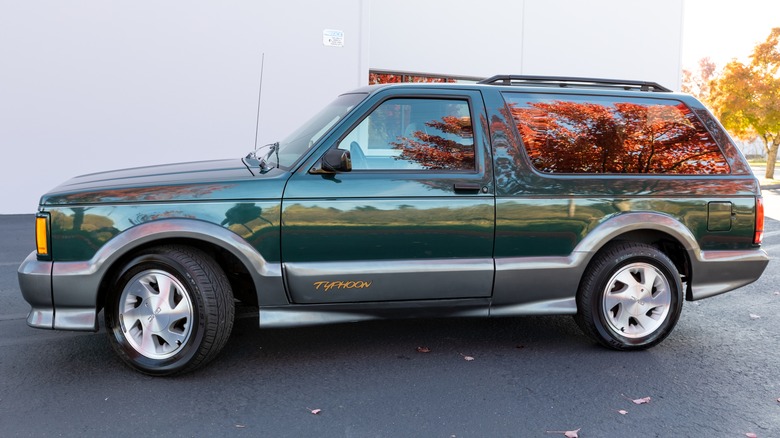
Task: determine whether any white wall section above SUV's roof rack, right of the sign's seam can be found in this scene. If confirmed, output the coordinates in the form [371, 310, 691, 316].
[371, 0, 683, 89]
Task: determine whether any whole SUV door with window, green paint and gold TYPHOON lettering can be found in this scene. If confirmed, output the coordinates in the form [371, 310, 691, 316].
[282, 88, 495, 303]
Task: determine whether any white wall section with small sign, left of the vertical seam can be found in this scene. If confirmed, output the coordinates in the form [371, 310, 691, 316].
[0, 0, 370, 214]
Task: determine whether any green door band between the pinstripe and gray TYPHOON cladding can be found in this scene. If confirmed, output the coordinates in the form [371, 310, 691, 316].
[283, 197, 494, 262]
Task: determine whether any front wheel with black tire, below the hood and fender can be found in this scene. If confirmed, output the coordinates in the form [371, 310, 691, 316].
[104, 245, 235, 376]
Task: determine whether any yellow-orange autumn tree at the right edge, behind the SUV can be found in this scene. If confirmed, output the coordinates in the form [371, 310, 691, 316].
[710, 27, 780, 179]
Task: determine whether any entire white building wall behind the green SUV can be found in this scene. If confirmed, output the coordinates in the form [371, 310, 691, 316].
[0, 0, 683, 214]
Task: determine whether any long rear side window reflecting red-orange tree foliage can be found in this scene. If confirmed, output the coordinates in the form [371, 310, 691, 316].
[504, 93, 730, 175]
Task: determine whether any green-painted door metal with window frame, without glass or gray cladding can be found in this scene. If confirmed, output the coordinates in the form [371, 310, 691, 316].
[282, 87, 495, 263]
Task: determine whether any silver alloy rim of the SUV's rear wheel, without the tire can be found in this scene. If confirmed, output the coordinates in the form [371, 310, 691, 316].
[602, 263, 672, 338]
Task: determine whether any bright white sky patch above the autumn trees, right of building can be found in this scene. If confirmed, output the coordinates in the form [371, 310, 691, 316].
[682, 0, 780, 70]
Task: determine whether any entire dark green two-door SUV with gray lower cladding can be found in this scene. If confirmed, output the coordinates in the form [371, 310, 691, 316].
[19, 76, 768, 375]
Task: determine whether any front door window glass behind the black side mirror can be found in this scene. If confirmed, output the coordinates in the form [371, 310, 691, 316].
[338, 98, 476, 172]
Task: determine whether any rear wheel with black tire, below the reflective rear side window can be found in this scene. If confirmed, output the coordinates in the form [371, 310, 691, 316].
[574, 242, 683, 350]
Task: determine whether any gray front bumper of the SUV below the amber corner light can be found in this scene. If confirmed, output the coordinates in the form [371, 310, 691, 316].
[17, 251, 99, 331]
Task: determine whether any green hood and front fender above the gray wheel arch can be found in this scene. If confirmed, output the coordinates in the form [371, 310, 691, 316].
[41, 159, 290, 261]
